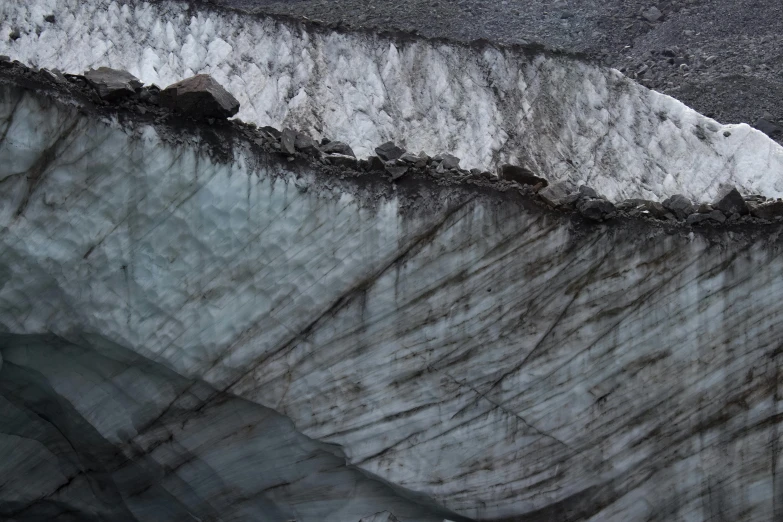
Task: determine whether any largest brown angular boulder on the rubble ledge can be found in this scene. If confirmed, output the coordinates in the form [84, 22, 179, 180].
[160, 74, 239, 118]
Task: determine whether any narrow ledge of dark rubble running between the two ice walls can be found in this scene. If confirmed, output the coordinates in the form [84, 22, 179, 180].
[0, 58, 783, 232]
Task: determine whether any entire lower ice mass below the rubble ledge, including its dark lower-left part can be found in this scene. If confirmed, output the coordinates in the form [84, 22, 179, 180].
[0, 62, 783, 522]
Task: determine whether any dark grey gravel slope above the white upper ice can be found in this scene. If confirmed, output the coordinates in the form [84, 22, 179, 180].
[211, 0, 783, 141]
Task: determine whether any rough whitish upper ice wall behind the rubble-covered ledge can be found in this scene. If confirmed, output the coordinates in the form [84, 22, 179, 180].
[0, 0, 783, 201]
